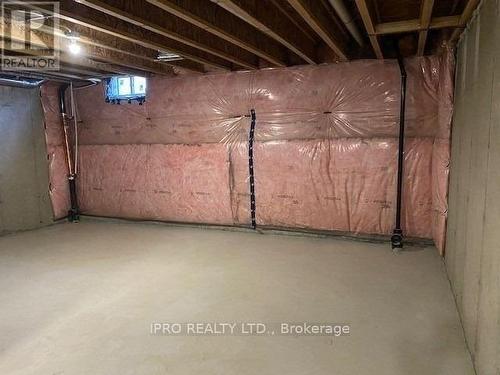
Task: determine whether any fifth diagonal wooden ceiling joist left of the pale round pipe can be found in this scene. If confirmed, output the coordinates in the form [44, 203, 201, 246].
[23, 0, 233, 70]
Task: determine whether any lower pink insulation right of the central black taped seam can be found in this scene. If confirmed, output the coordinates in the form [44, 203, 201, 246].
[237, 138, 432, 238]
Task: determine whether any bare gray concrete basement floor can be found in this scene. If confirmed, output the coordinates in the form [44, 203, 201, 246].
[0, 221, 473, 375]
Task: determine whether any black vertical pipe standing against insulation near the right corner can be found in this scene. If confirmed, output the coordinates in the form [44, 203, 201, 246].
[391, 57, 406, 249]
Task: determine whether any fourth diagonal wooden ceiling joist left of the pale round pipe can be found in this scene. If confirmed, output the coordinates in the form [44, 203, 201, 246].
[79, 0, 259, 69]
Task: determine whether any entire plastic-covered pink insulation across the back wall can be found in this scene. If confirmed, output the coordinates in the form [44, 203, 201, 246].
[41, 55, 453, 254]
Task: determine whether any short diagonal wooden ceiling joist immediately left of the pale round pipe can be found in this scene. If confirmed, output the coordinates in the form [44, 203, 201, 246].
[288, 0, 348, 61]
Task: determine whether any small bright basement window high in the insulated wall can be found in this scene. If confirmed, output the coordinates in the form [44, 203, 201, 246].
[106, 76, 147, 105]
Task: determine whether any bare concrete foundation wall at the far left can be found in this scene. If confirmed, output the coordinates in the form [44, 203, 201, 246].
[0, 86, 53, 235]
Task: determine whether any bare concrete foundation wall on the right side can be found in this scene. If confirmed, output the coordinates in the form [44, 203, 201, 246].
[446, 0, 500, 375]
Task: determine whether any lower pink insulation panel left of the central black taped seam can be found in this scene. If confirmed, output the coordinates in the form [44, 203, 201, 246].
[78, 144, 233, 225]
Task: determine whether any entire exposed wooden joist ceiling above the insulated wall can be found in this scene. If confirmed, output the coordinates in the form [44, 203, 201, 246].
[0, 0, 480, 76]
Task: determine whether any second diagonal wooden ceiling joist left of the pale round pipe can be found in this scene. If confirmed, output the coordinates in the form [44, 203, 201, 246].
[211, 0, 317, 64]
